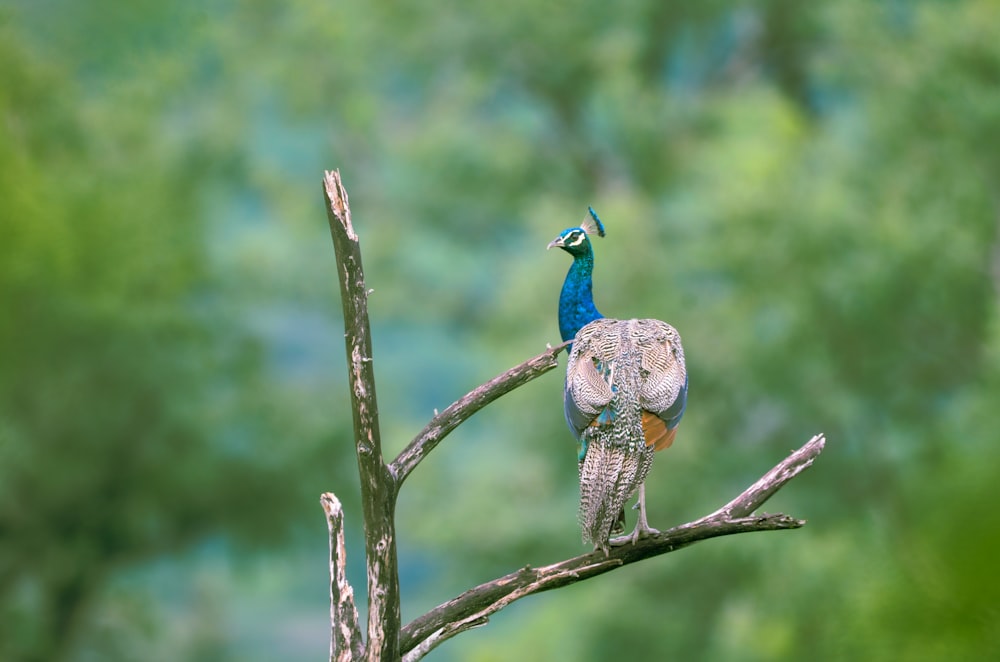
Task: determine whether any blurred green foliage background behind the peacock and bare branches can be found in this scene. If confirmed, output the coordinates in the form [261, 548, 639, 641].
[0, 0, 1000, 662]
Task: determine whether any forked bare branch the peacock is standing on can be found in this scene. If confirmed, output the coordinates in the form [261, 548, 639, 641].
[400, 435, 826, 660]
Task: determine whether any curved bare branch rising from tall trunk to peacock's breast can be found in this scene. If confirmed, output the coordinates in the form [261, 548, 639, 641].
[389, 341, 570, 485]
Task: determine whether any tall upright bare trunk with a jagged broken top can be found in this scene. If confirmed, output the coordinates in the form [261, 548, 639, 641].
[323, 170, 400, 662]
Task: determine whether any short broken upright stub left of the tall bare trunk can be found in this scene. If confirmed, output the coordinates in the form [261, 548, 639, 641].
[319, 492, 364, 662]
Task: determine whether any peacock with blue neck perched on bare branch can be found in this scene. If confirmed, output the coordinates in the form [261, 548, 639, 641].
[549, 208, 688, 554]
